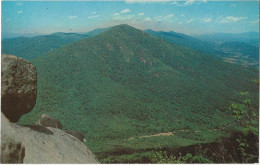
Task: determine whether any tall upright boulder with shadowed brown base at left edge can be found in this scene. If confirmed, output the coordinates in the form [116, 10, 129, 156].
[1, 54, 37, 122]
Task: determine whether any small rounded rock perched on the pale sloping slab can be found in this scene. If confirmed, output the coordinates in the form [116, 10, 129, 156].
[35, 114, 62, 129]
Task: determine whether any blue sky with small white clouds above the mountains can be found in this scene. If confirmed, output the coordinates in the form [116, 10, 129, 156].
[1, 0, 259, 37]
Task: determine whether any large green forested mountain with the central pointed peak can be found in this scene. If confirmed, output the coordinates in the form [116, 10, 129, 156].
[17, 25, 258, 162]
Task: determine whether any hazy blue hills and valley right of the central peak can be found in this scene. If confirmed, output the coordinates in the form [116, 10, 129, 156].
[146, 30, 259, 68]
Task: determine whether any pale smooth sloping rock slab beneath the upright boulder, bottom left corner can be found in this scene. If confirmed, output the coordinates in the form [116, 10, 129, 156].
[1, 114, 99, 164]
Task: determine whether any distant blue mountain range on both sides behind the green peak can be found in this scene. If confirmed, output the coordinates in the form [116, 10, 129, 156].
[2, 27, 259, 69]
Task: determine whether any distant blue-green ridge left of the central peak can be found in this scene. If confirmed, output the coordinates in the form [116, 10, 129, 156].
[2, 32, 88, 60]
